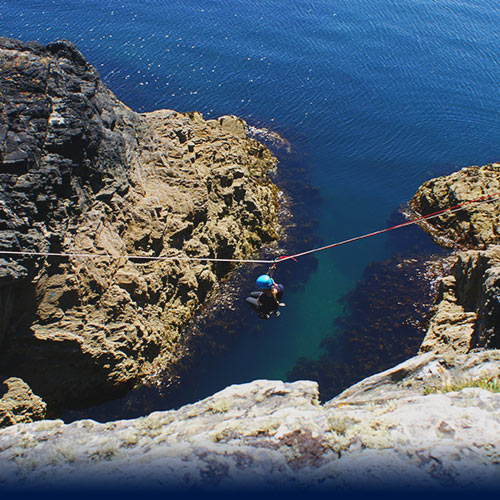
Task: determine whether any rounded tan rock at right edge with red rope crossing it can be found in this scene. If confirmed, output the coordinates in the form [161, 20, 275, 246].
[409, 163, 500, 248]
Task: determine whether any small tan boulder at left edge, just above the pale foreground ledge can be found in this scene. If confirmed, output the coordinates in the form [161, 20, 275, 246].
[0, 377, 47, 427]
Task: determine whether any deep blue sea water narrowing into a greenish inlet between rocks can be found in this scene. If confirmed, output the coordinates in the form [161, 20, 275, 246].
[0, 0, 500, 410]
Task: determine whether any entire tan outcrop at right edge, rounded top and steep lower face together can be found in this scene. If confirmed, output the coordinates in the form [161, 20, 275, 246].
[410, 163, 500, 353]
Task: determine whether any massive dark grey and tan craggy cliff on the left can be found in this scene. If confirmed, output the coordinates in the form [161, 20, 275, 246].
[0, 38, 277, 416]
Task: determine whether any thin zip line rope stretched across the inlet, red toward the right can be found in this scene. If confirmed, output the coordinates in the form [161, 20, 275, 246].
[0, 193, 500, 264]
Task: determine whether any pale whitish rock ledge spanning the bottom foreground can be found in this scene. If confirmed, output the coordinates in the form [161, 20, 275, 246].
[0, 351, 500, 490]
